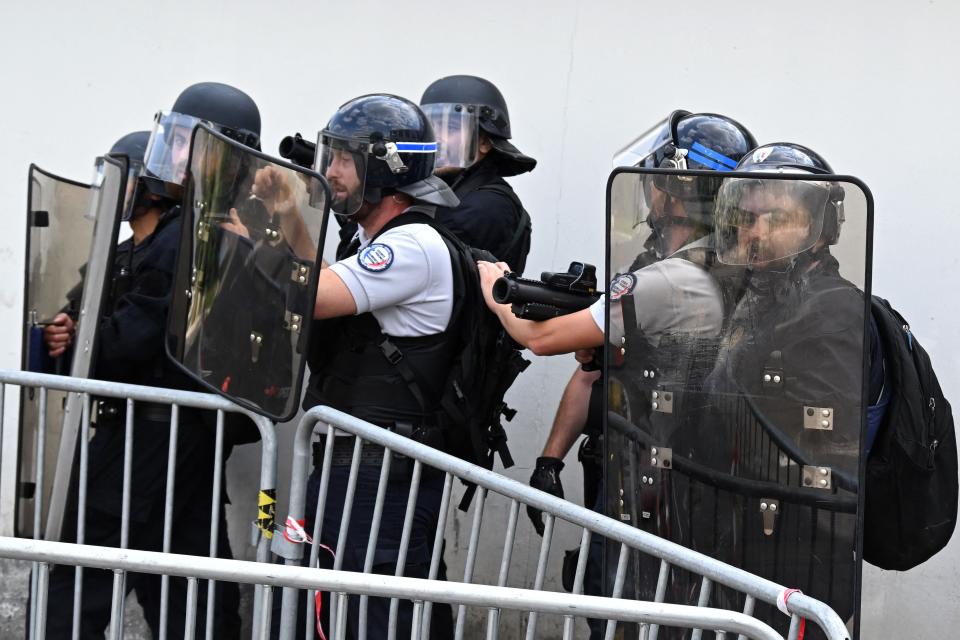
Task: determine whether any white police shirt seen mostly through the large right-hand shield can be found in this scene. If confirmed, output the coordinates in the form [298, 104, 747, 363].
[590, 237, 723, 347]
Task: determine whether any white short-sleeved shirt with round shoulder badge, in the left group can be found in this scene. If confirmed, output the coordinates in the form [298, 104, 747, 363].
[330, 215, 453, 338]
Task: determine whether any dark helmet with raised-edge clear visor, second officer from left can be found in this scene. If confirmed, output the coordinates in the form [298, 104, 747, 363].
[143, 82, 260, 199]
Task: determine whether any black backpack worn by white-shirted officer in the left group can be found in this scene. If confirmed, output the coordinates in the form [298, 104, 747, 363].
[381, 211, 530, 511]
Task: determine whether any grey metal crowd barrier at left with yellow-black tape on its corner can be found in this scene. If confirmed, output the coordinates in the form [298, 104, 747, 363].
[0, 371, 277, 640]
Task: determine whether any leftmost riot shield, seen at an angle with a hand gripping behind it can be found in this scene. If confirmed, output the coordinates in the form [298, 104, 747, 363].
[28, 157, 127, 540]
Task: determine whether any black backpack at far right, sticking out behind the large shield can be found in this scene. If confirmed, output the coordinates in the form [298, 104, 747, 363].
[863, 296, 958, 571]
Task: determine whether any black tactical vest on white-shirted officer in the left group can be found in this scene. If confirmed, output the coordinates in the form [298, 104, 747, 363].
[304, 208, 459, 426]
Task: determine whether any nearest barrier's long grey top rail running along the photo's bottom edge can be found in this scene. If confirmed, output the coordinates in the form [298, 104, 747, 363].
[0, 538, 782, 640]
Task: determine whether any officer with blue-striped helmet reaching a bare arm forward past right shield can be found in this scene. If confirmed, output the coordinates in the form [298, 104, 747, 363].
[480, 111, 756, 637]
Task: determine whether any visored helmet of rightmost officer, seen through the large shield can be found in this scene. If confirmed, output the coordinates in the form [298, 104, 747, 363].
[716, 143, 844, 272]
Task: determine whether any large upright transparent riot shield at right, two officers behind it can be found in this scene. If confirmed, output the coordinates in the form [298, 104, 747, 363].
[604, 169, 873, 637]
